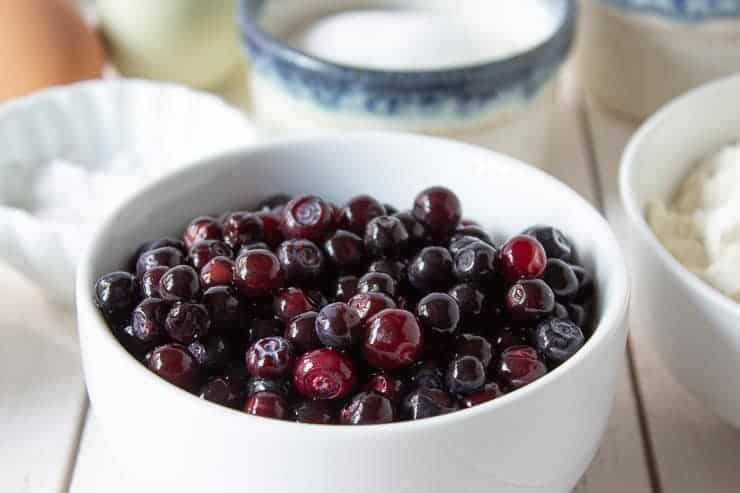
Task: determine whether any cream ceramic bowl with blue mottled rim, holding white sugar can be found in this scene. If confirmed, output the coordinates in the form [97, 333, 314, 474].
[238, 0, 576, 167]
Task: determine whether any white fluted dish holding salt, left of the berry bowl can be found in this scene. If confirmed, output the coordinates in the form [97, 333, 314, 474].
[0, 79, 256, 305]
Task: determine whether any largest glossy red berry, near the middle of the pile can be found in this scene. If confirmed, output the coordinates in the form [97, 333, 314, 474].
[362, 309, 423, 370]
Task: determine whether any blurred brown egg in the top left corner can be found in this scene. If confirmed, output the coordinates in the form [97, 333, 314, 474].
[0, 0, 105, 102]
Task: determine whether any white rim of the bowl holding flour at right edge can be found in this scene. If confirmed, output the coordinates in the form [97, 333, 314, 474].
[619, 75, 740, 319]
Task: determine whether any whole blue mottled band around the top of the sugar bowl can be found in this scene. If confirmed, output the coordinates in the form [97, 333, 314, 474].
[237, 0, 577, 118]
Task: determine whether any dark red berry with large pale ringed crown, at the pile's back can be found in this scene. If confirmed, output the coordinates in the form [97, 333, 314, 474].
[280, 195, 334, 242]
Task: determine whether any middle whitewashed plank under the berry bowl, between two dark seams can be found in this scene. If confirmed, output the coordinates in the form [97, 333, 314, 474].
[65, 69, 652, 493]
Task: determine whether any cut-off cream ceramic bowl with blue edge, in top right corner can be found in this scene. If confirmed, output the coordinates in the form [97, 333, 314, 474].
[579, 0, 740, 119]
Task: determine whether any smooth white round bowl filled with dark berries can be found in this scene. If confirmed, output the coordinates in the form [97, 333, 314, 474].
[77, 132, 628, 493]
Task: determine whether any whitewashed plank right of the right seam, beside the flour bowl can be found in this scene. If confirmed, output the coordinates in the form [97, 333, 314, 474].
[588, 100, 740, 493]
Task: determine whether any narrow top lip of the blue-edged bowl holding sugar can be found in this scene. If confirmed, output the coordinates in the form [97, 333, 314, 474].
[235, 0, 578, 80]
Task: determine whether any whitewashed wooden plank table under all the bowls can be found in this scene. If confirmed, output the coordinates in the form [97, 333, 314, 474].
[0, 67, 740, 493]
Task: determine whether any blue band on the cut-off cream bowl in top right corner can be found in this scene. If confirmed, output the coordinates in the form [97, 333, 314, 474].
[599, 0, 740, 23]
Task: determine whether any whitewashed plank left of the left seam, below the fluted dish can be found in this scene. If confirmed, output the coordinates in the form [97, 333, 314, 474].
[0, 264, 87, 493]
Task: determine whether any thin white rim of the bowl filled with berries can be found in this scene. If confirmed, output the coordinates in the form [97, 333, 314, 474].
[76, 131, 630, 430]
